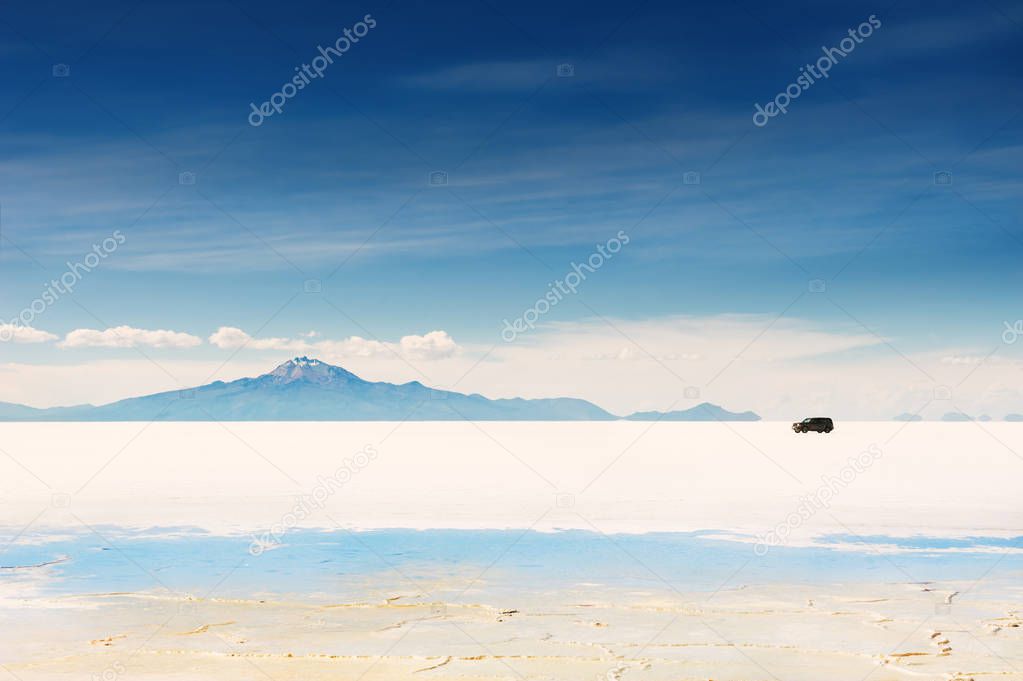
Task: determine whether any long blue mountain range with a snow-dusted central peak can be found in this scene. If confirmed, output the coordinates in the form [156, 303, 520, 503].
[0, 357, 760, 421]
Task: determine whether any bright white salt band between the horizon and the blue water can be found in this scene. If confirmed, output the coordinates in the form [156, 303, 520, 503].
[0, 421, 1023, 543]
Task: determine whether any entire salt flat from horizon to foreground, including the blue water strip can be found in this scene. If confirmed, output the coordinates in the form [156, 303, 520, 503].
[0, 422, 1023, 681]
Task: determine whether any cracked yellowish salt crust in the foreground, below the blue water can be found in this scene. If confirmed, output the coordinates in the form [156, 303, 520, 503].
[0, 572, 1023, 681]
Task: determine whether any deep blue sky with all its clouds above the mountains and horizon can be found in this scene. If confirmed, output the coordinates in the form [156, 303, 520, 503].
[0, 0, 1023, 420]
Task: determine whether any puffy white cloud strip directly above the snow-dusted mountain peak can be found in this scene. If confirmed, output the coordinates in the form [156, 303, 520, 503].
[210, 326, 459, 360]
